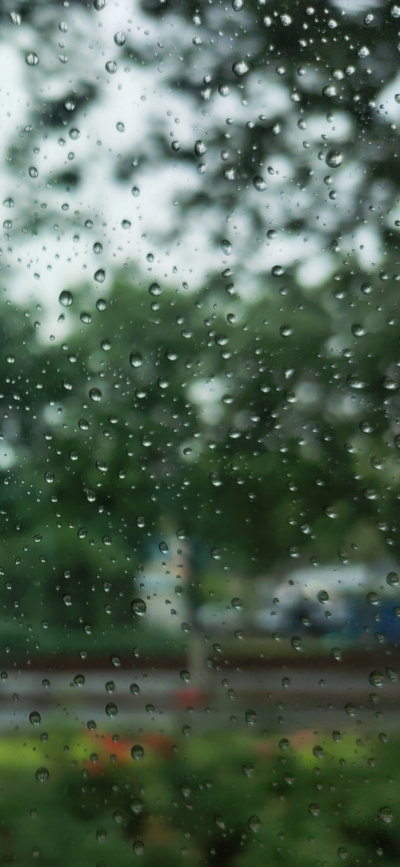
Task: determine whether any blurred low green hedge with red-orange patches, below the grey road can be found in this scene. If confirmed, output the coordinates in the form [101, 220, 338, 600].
[0, 731, 400, 867]
